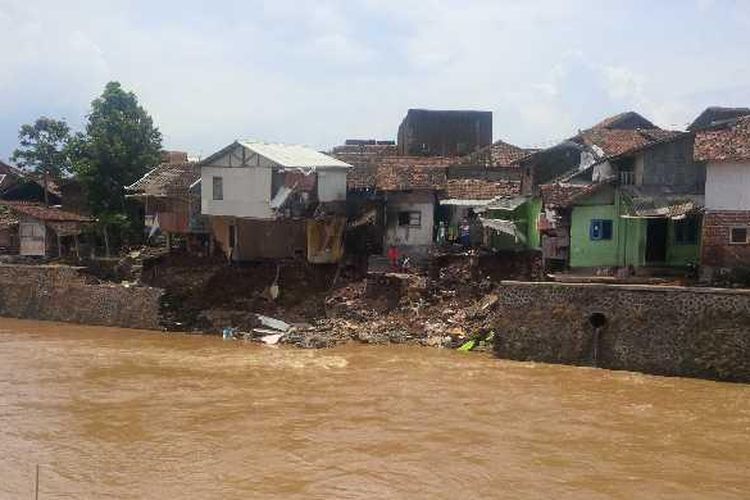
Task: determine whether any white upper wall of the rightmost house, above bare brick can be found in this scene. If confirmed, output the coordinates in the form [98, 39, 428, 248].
[706, 162, 750, 210]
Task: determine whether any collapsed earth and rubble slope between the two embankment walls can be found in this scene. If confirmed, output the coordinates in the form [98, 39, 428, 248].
[143, 252, 508, 348]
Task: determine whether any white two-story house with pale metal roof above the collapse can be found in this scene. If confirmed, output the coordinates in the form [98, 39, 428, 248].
[200, 141, 350, 263]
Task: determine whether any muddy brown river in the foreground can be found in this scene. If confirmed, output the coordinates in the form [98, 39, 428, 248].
[0, 318, 750, 500]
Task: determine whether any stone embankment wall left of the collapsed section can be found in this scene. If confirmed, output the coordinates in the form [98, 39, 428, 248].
[0, 265, 163, 330]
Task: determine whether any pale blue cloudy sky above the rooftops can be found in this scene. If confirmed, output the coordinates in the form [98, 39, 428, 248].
[0, 0, 750, 159]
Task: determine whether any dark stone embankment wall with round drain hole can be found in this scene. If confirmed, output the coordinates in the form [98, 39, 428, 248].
[495, 282, 750, 382]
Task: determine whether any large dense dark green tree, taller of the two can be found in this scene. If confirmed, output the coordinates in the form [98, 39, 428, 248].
[69, 82, 162, 254]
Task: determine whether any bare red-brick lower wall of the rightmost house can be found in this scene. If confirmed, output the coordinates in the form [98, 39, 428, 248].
[701, 211, 750, 268]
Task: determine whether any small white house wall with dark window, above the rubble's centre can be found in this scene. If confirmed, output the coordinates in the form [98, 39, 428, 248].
[385, 193, 435, 249]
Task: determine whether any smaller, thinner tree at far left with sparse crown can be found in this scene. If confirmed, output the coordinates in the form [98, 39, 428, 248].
[11, 116, 71, 206]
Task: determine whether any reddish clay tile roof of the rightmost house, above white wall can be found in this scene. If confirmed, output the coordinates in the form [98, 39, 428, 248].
[693, 117, 750, 161]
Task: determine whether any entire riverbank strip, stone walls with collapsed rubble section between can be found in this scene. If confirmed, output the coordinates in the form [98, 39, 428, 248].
[0, 254, 750, 382]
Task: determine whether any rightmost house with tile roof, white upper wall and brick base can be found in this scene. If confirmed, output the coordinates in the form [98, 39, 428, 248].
[695, 117, 750, 280]
